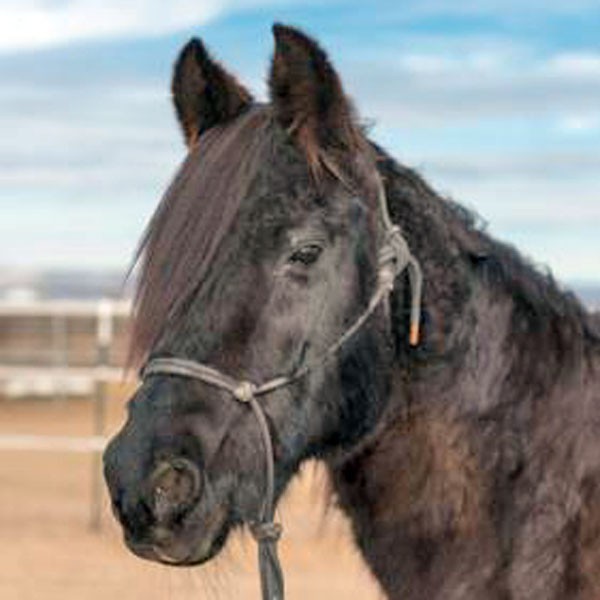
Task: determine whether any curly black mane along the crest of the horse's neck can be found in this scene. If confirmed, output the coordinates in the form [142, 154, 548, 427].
[375, 146, 600, 370]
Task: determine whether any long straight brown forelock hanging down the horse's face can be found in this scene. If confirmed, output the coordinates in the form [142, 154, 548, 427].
[129, 106, 272, 365]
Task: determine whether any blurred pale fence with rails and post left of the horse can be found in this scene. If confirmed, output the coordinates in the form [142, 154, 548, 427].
[0, 300, 130, 529]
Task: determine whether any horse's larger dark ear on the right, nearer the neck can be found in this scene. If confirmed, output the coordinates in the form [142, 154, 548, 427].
[269, 24, 362, 169]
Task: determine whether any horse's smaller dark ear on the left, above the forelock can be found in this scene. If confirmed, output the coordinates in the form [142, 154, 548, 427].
[171, 38, 252, 146]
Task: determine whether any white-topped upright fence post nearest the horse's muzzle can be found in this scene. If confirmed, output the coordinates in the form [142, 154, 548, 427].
[90, 299, 114, 531]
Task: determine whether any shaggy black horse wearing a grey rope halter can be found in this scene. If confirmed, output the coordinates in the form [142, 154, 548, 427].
[104, 25, 600, 600]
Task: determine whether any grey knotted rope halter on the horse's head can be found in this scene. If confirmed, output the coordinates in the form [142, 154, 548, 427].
[141, 180, 423, 600]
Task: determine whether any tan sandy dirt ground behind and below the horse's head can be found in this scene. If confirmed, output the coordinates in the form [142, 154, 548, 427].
[0, 391, 381, 600]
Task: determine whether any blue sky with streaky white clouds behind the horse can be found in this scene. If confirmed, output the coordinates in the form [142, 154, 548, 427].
[0, 0, 600, 282]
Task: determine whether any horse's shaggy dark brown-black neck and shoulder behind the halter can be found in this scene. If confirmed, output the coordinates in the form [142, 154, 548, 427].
[330, 149, 600, 600]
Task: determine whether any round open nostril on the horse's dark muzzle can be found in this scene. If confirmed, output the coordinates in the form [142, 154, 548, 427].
[150, 458, 202, 522]
